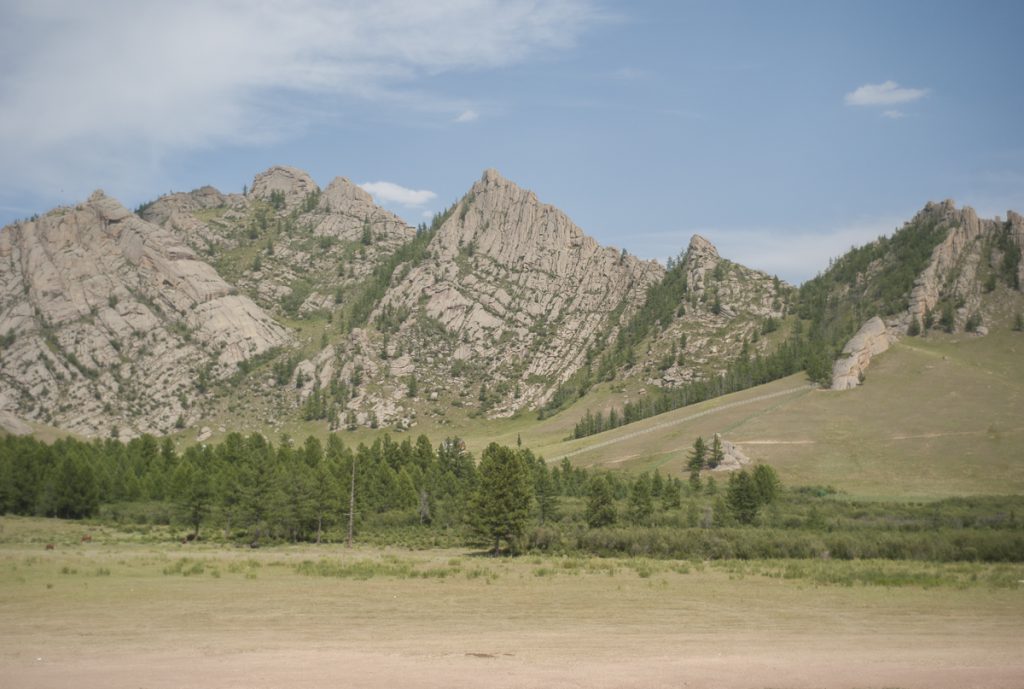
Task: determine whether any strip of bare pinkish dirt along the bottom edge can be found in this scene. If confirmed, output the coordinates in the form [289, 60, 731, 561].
[5, 637, 1024, 689]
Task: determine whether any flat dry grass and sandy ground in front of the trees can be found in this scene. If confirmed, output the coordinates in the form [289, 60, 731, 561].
[0, 549, 1024, 689]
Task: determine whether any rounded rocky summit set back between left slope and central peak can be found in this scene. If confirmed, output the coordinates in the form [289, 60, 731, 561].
[140, 166, 416, 318]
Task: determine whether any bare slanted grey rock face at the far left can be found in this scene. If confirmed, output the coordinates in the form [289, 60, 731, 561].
[0, 191, 289, 435]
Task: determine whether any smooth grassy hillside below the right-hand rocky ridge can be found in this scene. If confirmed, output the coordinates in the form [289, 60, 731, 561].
[540, 332, 1024, 500]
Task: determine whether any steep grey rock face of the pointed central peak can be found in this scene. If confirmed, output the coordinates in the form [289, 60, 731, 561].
[358, 170, 664, 415]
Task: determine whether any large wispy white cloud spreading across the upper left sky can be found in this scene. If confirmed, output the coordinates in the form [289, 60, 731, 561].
[0, 0, 601, 198]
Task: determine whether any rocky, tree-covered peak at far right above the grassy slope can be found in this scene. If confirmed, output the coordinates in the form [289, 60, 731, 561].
[815, 200, 1024, 389]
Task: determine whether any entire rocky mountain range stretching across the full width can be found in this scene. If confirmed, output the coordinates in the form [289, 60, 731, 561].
[0, 166, 1024, 436]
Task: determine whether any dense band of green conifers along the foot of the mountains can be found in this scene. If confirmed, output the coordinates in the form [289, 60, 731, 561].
[0, 433, 778, 552]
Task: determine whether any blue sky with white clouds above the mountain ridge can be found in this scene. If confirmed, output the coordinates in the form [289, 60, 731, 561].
[0, 0, 1024, 283]
